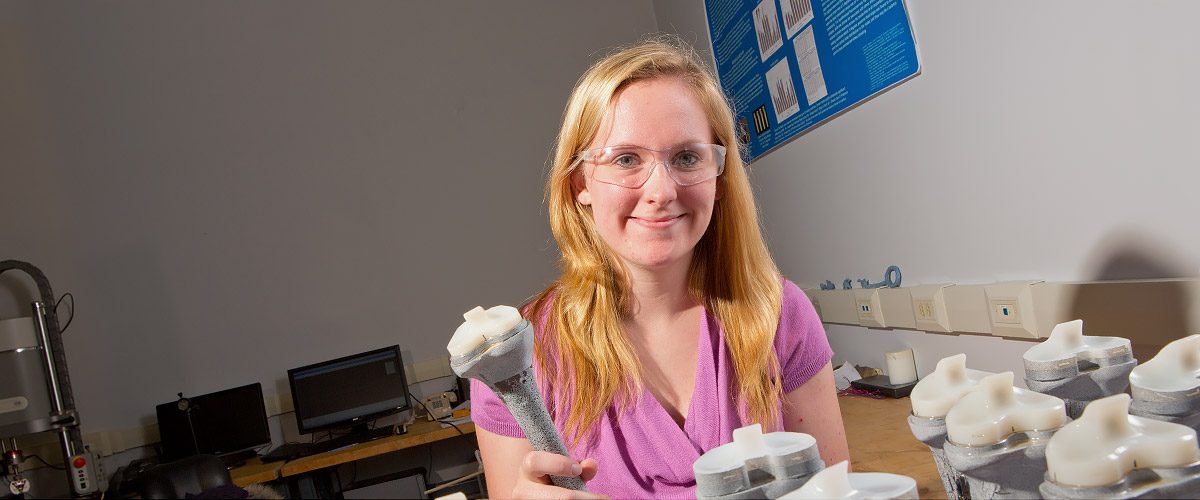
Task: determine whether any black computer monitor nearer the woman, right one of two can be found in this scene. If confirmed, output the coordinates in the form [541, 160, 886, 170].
[288, 345, 409, 434]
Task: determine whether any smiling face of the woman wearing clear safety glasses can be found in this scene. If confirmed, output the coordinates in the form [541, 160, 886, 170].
[572, 78, 720, 273]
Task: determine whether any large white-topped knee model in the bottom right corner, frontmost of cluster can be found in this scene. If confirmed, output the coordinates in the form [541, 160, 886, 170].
[1040, 393, 1200, 498]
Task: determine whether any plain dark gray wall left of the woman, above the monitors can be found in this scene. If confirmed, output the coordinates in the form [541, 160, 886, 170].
[0, 0, 655, 433]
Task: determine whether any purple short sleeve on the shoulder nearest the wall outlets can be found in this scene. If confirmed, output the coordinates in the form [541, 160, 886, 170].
[775, 279, 833, 394]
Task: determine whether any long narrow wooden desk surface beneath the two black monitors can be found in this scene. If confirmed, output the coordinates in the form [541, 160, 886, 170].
[229, 421, 475, 487]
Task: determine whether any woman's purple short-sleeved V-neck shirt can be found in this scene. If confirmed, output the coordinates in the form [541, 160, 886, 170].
[470, 279, 833, 499]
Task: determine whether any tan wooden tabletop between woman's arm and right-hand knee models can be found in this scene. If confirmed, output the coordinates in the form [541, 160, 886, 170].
[838, 396, 948, 499]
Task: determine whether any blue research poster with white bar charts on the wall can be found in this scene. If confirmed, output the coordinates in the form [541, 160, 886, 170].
[704, 0, 920, 161]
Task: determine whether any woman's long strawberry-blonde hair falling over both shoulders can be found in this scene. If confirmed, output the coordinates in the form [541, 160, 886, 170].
[527, 37, 782, 444]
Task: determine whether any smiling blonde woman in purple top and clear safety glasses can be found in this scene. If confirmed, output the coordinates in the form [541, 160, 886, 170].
[472, 40, 848, 498]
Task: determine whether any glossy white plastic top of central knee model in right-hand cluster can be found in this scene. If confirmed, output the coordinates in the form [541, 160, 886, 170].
[946, 372, 1068, 446]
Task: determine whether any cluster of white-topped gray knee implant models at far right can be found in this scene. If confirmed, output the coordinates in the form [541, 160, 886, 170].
[908, 320, 1200, 499]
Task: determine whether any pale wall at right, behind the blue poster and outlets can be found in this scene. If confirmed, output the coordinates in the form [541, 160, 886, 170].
[655, 0, 1200, 380]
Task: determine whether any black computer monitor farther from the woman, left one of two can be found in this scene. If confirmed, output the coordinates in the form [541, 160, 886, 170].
[155, 382, 271, 460]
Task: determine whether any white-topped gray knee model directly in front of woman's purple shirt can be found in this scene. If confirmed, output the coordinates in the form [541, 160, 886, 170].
[691, 423, 824, 499]
